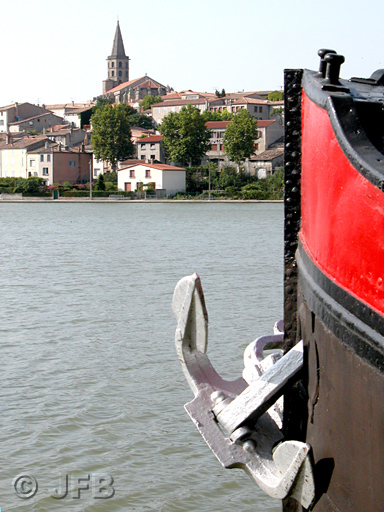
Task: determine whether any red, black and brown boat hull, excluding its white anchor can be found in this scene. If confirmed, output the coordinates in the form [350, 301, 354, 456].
[284, 57, 384, 512]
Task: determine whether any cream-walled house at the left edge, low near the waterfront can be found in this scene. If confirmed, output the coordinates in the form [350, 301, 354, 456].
[0, 136, 53, 178]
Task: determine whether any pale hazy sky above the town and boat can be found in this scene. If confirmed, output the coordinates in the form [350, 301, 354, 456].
[0, 0, 384, 106]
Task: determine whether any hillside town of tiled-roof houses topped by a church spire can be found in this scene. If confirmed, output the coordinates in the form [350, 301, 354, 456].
[0, 22, 284, 197]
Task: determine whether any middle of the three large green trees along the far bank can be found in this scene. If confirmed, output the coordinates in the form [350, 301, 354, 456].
[159, 105, 211, 167]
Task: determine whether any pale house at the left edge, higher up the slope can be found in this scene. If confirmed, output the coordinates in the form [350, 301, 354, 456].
[0, 103, 62, 132]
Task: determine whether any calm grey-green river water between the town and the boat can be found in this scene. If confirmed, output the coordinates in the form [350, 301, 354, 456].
[0, 203, 283, 512]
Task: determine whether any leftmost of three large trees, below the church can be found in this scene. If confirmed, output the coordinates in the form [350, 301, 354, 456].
[91, 103, 134, 171]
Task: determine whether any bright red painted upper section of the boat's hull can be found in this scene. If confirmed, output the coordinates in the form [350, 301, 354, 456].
[300, 92, 384, 314]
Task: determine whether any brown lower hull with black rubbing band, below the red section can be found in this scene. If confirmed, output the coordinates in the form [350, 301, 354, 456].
[285, 243, 384, 512]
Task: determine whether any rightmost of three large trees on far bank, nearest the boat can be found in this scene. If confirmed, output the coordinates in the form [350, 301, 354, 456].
[223, 109, 258, 170]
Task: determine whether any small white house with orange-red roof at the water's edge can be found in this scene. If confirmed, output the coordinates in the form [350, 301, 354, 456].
[117, 163, 186, 195]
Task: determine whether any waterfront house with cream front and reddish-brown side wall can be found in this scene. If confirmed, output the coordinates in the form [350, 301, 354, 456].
[27, 143, 92, 185]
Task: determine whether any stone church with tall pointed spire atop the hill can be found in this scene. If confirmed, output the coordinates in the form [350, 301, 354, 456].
[103, 22, 169, 103]
